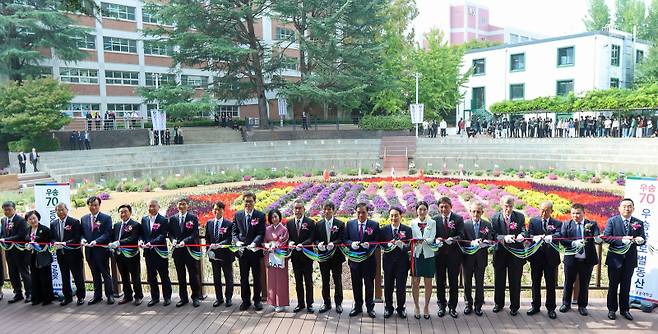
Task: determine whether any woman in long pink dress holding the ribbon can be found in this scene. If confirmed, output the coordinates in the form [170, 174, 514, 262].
[264, 210, 290, 312]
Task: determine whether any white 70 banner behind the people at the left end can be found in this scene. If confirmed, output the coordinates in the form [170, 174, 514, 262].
[34, 183, 71, 294]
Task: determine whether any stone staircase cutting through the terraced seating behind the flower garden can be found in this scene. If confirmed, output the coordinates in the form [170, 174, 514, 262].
[379, 136, 416, 173]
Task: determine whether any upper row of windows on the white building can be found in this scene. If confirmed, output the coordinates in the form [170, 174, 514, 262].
[473, 44, 644, 75]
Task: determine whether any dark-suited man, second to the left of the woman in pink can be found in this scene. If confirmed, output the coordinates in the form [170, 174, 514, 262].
[206, 201, 235, 307]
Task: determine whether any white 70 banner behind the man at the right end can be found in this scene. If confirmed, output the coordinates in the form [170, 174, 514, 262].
[625, 177, 658, 303]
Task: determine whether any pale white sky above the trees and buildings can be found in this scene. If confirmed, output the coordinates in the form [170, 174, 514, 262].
[414, 0, 651, 41]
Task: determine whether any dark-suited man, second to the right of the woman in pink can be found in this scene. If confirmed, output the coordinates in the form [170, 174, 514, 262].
[315, 200, 345, 314]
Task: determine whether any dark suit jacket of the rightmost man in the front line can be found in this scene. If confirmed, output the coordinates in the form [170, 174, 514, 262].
[603, 215, 647, 268]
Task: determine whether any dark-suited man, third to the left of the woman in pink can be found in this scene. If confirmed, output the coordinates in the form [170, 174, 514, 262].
[169, 198, 201, 307]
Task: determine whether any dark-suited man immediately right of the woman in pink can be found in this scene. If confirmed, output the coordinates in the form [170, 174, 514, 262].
[286, 200, 315, 313]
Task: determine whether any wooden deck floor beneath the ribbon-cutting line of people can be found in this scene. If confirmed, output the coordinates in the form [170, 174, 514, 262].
[0, 290, 658, 334]
